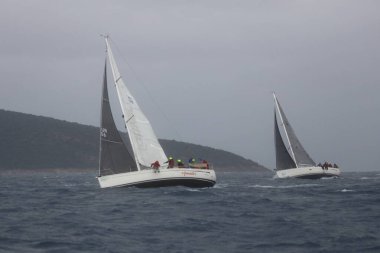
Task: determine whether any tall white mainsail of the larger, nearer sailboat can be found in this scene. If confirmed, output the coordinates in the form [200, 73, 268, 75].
[105, 37, 167, 170]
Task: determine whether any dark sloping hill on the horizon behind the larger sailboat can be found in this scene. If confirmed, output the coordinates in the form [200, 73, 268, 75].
[0, 110, 266, 171]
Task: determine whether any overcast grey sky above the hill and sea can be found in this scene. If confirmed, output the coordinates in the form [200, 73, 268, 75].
[0, 0, 380, 171]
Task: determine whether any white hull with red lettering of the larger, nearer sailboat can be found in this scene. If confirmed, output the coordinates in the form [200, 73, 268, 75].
[98, 168, 216, 188]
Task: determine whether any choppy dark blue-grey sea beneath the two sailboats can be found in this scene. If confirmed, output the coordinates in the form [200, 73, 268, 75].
[0, 171, 380, 253]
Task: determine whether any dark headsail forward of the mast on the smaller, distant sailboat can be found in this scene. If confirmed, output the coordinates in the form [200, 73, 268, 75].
[274, 110, 297, 170]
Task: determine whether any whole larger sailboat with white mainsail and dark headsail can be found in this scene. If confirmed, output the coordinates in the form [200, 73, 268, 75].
[97, 36, 216, 188]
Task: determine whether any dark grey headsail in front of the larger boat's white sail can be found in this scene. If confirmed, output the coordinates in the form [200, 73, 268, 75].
[99, 63, 137, 176]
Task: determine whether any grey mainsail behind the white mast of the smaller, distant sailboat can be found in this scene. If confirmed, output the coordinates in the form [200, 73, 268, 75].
[277, 100, 315, 167]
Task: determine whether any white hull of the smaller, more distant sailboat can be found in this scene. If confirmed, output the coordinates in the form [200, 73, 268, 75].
[276, 166, 340, 179]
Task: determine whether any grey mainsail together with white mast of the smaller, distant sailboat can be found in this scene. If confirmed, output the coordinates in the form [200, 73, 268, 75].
[273, 94, 315, 167]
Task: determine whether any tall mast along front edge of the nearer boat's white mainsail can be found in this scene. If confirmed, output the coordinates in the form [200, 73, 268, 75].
[104, 35, 141, 170]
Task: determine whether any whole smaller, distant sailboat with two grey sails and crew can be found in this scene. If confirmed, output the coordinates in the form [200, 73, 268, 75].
[273, 93, 340, 179]
